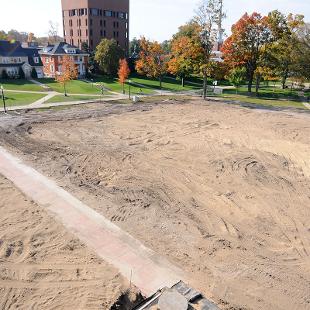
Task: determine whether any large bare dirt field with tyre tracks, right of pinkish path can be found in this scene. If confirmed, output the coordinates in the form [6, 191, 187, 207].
[0, 101, 310, 310]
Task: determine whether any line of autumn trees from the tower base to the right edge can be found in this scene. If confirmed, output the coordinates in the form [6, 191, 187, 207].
[91, 0, 310, 97]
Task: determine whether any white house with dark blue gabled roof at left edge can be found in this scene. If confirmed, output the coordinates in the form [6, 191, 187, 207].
[0, 40, 43, 78]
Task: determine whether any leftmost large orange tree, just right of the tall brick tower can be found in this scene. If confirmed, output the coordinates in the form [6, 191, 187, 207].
[136, 37, 169, 88]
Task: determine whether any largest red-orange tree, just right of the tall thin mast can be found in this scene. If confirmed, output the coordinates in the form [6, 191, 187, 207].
[222, 13, 272, 92]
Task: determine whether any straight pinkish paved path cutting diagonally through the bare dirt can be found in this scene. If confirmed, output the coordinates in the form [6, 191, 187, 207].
[0, 146, 186, 296]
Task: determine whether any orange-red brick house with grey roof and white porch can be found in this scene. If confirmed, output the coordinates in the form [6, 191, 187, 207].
[40, 42, 89, 78]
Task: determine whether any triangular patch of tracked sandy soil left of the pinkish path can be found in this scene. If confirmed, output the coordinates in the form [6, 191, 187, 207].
[0, 176, 132, 310]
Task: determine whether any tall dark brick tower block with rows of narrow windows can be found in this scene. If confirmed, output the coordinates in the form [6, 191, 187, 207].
[61, 0, 129, 52]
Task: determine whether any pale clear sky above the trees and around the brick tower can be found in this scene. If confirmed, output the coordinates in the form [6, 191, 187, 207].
[0, 0, 310, 41]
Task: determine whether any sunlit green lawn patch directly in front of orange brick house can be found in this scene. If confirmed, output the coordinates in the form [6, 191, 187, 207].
[40, 79, 100, 94]
